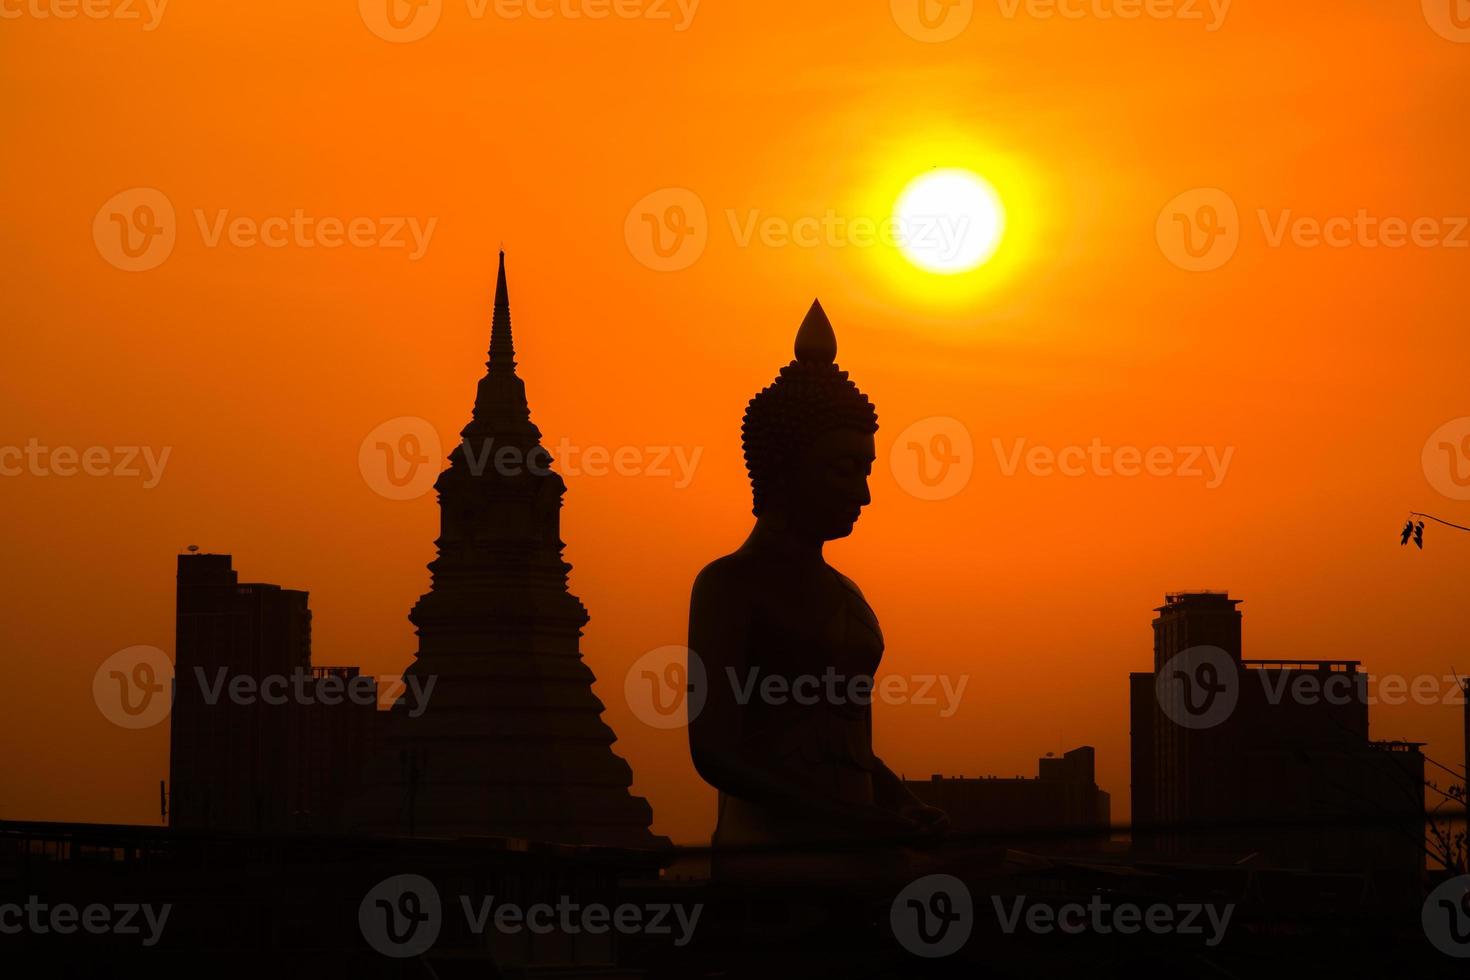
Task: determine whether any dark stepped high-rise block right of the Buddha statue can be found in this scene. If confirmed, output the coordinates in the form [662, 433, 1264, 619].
[1129, 592, 1424, 887]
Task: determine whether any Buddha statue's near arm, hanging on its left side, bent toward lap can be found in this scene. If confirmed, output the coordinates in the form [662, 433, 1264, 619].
[689, 563, 917, 835]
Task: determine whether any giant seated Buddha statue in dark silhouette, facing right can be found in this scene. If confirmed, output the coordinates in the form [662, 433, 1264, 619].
[689, 303, 948, 876]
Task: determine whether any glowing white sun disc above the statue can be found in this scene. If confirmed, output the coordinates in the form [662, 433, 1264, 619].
[894, 169, 1005, 275]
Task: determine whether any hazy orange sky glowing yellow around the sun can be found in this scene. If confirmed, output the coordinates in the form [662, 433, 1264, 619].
[0, 0, 1470, 840]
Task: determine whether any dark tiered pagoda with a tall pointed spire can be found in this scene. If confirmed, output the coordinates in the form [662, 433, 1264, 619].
[353, 251, 667, 848]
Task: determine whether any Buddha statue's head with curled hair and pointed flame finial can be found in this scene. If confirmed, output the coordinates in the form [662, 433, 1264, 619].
[741, 303, 878, 542]
